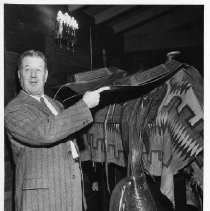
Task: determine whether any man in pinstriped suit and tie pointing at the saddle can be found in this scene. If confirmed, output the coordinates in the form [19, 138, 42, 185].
[5, 50, 109, 211]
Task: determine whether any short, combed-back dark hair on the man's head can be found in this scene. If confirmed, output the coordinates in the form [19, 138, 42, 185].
[18, 50, 47, 70]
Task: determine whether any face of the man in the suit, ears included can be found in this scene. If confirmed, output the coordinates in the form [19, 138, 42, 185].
[18, 56, 48, 96]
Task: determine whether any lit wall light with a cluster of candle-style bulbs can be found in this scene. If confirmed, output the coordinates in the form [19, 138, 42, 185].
[54, 11, 79, 52]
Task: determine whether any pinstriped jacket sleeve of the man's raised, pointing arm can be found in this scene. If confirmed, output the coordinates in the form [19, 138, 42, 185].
[5, 100, 93, 145]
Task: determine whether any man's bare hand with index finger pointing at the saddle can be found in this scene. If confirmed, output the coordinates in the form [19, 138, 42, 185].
[82, 86, 110, 108]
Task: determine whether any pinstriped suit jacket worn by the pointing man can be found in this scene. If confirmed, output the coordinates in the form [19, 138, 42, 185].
[5, 91, 93, 211]
